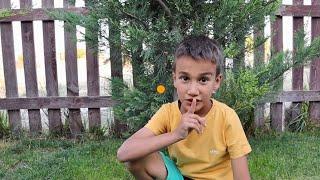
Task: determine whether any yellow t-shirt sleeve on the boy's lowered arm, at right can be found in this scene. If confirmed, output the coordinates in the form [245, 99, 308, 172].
[225, 110, 251, 159]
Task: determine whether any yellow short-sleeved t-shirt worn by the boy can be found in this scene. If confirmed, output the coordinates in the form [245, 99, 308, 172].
[145, 99, 251, 180]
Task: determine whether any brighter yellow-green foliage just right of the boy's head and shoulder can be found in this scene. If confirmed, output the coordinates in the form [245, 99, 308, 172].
[216, 67, 271, 132]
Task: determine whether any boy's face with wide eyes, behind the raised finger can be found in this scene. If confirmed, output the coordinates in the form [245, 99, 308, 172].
[173, 56, 222, 116]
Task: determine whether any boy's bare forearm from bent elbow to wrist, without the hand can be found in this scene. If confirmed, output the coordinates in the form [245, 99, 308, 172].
[117, 133, 181, 162]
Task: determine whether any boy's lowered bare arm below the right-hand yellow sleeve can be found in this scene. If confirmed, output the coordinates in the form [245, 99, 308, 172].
[231, 156, 250, 180]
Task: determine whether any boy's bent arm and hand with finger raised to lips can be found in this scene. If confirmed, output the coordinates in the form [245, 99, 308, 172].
[117, 99, 205, 162]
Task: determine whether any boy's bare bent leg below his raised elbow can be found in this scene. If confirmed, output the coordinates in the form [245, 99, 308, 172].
[125, 152, 167, 180]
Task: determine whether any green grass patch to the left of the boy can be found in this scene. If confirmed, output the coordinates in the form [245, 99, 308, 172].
[0, 139, 132, 179]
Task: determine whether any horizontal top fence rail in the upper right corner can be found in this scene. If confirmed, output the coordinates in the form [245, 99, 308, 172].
[276, 4, 320, 17]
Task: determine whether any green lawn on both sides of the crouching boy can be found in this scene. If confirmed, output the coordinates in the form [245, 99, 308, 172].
[0, 133, 320, 180]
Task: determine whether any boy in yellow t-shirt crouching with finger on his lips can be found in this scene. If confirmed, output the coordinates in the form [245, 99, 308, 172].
[117, 36, 251, 180]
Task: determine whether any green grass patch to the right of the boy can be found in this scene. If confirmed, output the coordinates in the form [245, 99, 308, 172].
[249, 132, 320, 180]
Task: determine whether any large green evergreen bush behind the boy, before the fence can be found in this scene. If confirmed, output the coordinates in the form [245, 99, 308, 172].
[54, 0, 320, 135]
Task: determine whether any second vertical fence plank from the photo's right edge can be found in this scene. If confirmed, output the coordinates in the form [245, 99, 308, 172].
[291, 0, 303, 125]
